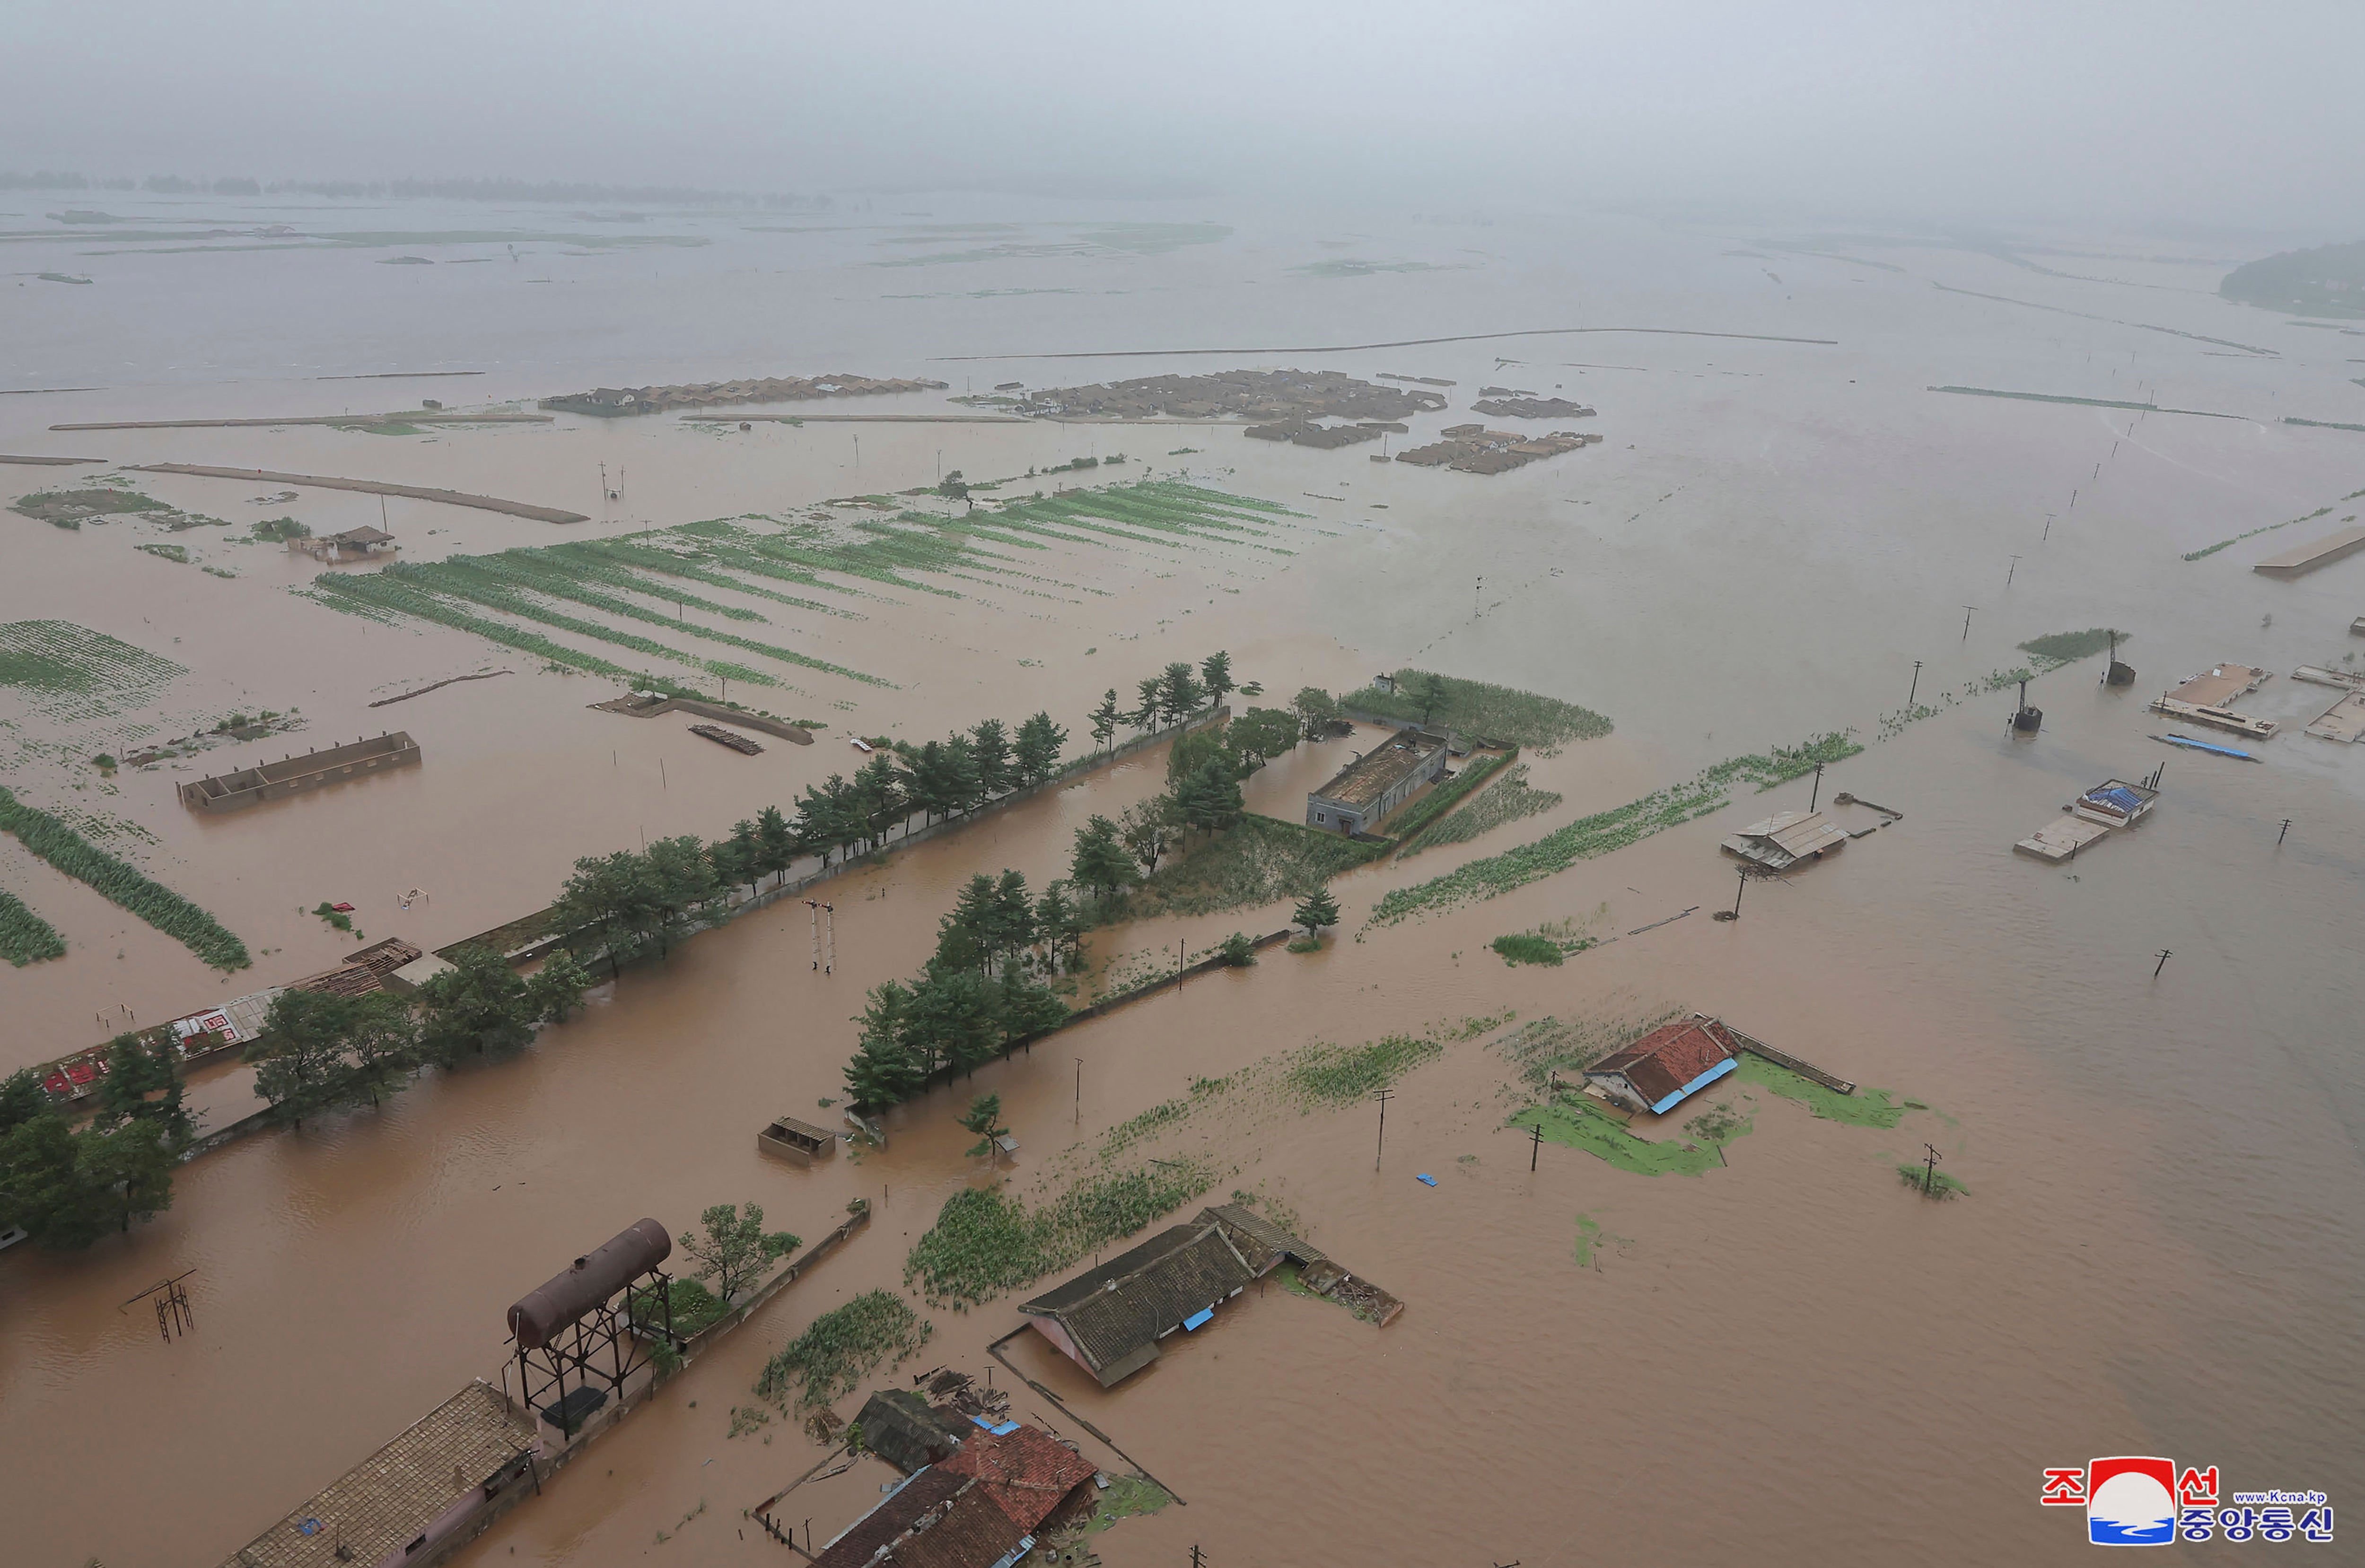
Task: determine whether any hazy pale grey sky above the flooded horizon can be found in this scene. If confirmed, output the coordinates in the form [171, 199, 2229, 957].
[0, 0, 2365, 236]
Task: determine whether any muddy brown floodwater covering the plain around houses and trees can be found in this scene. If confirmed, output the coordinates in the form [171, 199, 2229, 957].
[0, 196, 2365, 1568]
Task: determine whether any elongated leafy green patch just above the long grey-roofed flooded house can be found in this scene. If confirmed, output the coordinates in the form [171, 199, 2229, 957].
[903, 1161, 1216, 1313]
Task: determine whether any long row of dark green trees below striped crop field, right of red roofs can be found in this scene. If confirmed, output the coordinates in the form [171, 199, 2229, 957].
[556, 650, 1237, 972]
